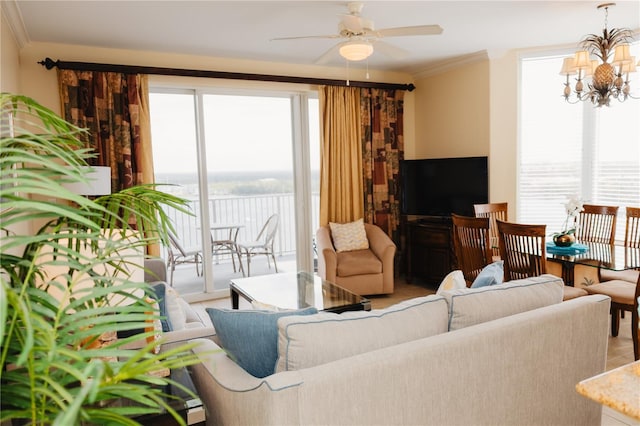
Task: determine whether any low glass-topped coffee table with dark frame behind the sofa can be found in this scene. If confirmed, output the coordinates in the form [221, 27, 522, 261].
[230, 272, 371, 313]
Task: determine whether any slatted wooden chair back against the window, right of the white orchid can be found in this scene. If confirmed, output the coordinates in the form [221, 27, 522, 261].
[576, 204, 618, 244]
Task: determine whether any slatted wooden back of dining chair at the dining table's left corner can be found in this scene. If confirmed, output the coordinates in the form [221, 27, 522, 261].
[496, 219, 547, 281]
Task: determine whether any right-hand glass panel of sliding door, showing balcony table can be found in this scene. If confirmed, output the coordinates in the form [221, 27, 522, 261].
[202, 94, 296, 290]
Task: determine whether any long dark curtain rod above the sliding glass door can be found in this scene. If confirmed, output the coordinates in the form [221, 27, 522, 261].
[38, 58, 416, 92]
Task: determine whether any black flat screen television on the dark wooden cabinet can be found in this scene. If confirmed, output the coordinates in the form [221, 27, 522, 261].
[400, 157, 489, 217]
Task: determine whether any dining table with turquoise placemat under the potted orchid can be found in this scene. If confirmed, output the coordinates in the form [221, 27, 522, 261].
[546, 241, 640, 286]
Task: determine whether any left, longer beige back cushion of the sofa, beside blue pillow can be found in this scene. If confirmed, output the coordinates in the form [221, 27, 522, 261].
[276, 295, 448, 372]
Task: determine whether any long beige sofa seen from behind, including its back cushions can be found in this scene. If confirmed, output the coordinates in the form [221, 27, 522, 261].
[192, 275, 610, 426]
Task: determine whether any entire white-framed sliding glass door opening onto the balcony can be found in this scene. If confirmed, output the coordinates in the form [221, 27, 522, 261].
[150, 89, 319, 296]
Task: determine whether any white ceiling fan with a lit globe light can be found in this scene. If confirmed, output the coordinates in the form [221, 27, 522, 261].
[272, 2, 442, 64]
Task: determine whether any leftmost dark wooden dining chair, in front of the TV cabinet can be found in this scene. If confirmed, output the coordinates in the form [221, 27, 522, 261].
[451, 214, 493, 287]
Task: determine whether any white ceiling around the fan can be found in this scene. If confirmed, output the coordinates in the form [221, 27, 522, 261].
[2, 0, 640, 72]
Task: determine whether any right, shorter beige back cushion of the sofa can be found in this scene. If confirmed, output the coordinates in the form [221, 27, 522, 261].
[441, 274, 564, 331]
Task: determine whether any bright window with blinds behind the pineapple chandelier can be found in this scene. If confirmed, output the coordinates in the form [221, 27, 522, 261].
[517, 43, 640, 240]
